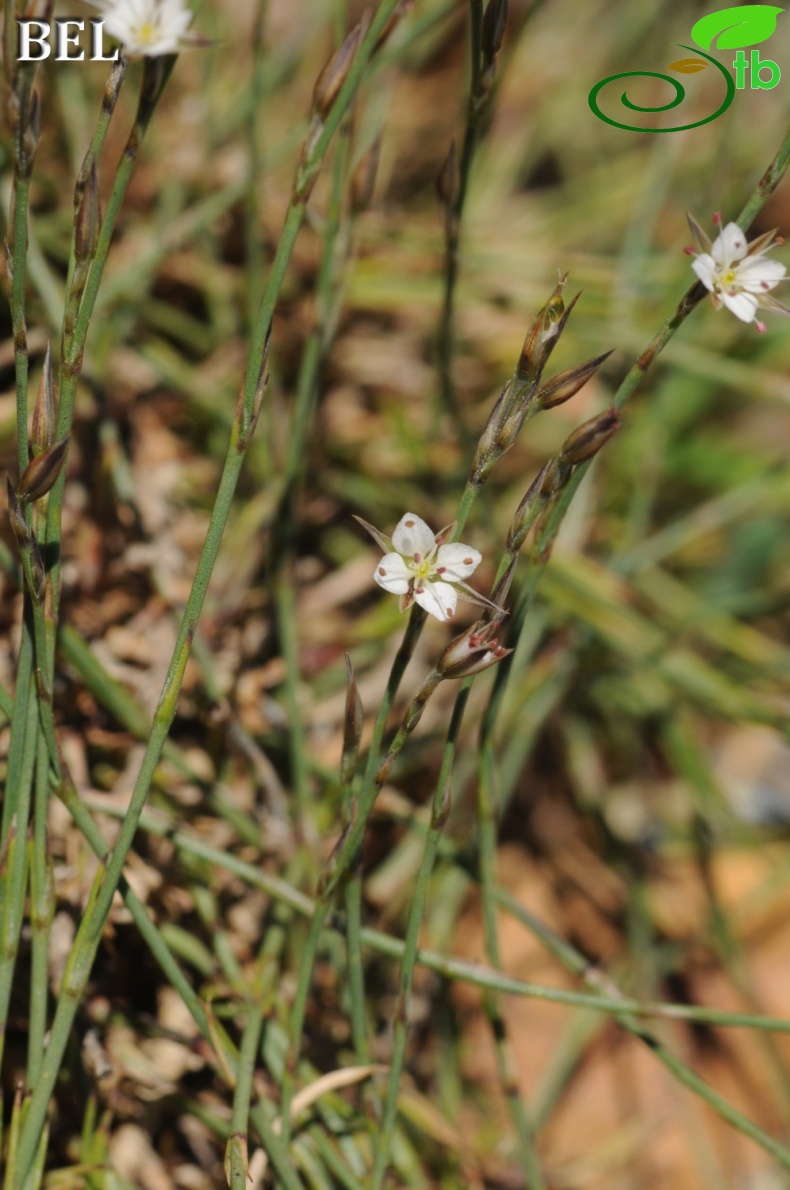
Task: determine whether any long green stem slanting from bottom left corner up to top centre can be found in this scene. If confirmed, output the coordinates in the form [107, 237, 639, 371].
[14, 0, 397, 1190]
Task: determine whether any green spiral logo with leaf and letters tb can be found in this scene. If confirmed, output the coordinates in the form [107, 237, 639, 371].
[588, 4, 784, 132]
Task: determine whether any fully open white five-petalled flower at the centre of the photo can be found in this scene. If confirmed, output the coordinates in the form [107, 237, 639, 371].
[356, 513, 491, 620]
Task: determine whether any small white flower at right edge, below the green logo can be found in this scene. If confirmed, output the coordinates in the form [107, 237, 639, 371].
[685, 215, 790, 332]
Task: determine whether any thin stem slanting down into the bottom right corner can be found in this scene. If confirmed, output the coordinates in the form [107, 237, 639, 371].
[496, 889, 790, 1170]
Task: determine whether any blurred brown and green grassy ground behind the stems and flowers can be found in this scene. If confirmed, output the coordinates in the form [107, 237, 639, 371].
[0, 0, 790, 1190]
